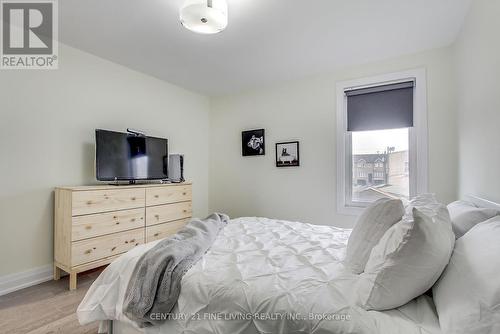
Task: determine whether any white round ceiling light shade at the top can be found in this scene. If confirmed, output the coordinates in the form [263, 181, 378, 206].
[180, 0, 227, 34]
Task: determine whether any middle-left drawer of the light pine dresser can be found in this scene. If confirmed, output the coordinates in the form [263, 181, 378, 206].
[71, 208, 145, 241]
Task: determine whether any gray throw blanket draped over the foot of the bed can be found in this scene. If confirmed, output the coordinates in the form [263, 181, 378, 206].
[123, 213, 229, 327]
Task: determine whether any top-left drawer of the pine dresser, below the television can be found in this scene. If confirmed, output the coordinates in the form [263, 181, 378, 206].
[72, 187, 146, 216]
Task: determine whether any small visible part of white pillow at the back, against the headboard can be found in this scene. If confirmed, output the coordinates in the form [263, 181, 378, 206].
[448, 201, 499, 238]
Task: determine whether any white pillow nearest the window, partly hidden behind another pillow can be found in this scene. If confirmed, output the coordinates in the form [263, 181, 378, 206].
[345, 198, 405, 274]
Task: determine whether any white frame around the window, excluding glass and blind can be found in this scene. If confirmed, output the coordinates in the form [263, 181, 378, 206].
[336, 68, 428, 215]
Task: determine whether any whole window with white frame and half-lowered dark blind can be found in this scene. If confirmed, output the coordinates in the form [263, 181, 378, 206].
[337, 70, 427, 214]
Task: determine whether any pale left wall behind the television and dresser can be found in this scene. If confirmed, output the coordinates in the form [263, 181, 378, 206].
[0, 45, 209, 276]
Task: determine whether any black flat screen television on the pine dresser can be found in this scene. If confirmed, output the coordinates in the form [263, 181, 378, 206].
[95, 129, 168, 181]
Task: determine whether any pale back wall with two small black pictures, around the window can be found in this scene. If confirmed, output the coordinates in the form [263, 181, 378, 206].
[209, 48, 457, 226]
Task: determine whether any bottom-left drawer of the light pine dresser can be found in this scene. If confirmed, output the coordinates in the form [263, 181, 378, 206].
[71, 228, 144, 266]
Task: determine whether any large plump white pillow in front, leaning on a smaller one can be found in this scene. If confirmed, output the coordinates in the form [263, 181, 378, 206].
[355, 205, 455, 311]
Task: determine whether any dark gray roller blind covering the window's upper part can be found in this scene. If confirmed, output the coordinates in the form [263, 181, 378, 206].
[345, 81, 415, 131]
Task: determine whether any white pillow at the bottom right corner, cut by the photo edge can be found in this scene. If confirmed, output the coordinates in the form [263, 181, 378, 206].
[433, 216, 500, 334]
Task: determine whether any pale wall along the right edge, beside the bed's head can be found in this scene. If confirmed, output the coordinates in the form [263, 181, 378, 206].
[455, 0, 500, 202]
